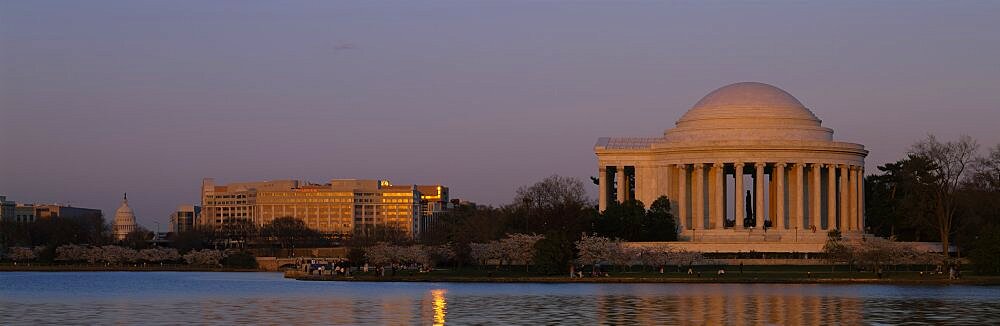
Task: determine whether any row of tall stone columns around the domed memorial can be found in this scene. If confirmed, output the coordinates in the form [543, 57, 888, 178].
[599, 161, 864, 231]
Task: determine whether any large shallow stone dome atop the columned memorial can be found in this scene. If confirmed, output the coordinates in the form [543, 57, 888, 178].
[664, 82, 833, 141]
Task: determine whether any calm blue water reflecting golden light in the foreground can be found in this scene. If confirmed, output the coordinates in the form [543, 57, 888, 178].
[0, 272, 1000, 325]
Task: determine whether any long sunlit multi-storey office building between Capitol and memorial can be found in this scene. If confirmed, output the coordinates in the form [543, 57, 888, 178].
[199, 179, 444, 237]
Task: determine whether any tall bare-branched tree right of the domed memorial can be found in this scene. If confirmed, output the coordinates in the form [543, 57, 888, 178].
[910, 135, 979, 257]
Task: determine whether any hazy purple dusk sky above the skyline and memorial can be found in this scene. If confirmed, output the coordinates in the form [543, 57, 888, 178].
[0, 0, 1000, 230]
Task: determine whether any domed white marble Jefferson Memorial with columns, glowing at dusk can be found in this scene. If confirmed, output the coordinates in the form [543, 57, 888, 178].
[594, 82, 868, 252]
